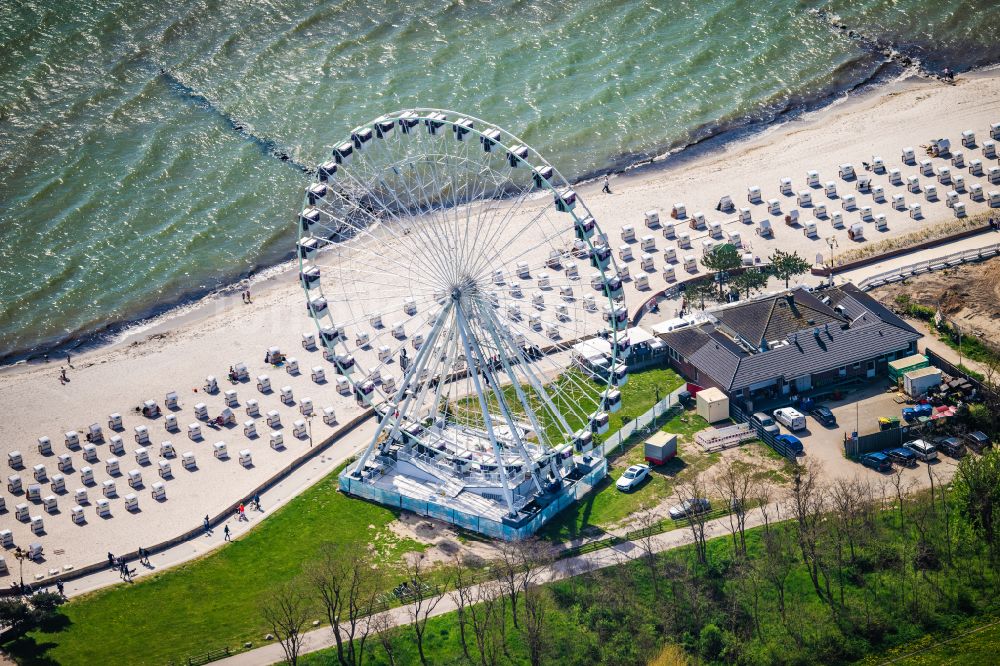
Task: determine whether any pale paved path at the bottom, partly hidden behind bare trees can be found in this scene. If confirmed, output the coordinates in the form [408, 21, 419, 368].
[219, 505, 778, 666]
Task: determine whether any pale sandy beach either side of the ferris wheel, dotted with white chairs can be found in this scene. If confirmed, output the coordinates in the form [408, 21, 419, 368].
[0, 72, 1000, 580]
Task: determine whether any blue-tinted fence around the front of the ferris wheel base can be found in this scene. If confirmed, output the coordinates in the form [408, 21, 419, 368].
[340, 458, 608, 541]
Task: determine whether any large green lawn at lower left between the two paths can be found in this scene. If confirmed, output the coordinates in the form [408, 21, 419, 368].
[3, 470, 424, 664]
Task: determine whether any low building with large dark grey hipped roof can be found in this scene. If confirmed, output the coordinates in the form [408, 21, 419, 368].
[660, 284, 921, 401]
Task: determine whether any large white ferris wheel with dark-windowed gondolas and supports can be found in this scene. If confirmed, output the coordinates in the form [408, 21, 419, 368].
[298, 109, 628, 516]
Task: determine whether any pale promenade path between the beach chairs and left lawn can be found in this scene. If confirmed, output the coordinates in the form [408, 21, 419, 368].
[59, 419, 375, 597]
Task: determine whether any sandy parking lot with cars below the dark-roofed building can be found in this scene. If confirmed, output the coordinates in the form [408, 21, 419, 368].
[764, 377, 958, 486]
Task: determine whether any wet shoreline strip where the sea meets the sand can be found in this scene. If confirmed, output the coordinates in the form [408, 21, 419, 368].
[0, 62, 1000, 374]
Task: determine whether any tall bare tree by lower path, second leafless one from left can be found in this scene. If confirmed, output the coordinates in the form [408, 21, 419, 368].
[306, 542, 379, 666]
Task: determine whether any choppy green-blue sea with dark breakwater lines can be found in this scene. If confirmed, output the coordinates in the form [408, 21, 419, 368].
[0, 0, 1000, 361]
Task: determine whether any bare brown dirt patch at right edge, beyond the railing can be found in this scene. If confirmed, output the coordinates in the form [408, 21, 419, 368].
[872, 258, 1000, 348]
